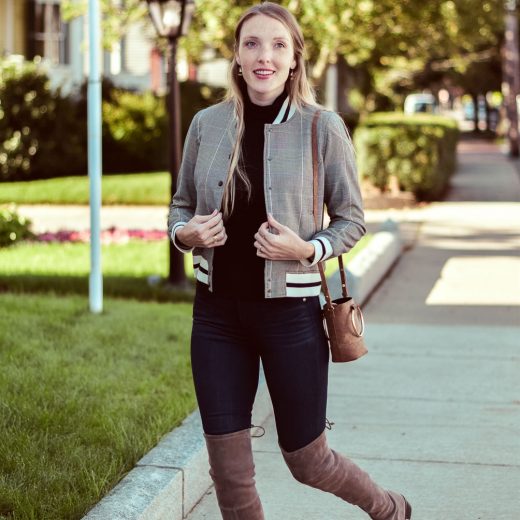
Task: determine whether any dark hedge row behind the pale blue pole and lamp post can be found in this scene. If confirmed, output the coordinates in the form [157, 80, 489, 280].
[0, 59, 224, 181]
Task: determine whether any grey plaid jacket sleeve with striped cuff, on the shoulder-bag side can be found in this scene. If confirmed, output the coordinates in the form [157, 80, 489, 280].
[302, 112, 366, 266]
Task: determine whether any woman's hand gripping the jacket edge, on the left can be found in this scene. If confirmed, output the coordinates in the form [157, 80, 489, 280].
[175, 210, 227, 247]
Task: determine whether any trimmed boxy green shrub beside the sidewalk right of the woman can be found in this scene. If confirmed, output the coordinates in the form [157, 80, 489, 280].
[354, 113, 459, 200]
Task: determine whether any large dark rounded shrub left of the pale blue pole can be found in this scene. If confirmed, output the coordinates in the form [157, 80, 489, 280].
[0, 60, 86, 180]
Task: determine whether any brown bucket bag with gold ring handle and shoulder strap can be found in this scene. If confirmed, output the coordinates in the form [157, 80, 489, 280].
[312, 110, 368, 363]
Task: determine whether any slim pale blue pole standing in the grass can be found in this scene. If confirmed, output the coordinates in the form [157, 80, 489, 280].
[88, 0, 103, 313]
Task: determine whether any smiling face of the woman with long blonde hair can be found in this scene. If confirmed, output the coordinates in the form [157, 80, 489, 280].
[236, 14, 296, 105]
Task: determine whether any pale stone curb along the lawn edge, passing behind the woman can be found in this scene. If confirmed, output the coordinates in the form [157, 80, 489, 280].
[83, 223, 402, 520]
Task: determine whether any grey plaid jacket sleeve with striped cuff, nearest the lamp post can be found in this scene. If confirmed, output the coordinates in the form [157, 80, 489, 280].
[168, 112, 201, 253]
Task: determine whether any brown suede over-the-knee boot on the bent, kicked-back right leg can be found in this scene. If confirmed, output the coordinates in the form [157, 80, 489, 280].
[278, 431, 412, 520]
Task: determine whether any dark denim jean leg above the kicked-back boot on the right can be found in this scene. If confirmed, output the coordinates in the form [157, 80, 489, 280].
[251, 298, 329, 451]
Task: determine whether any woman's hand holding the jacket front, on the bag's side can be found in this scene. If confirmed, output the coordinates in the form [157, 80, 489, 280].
[255, 214, 314, 260]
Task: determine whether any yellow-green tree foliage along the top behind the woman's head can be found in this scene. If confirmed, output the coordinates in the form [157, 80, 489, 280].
[62, 0, 504, 108]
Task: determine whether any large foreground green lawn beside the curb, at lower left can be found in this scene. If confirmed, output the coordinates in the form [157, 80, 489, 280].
[0, 294, 196, 520]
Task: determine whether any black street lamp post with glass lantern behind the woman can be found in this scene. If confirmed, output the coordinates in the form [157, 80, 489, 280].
[146, 0, 195, 286]
